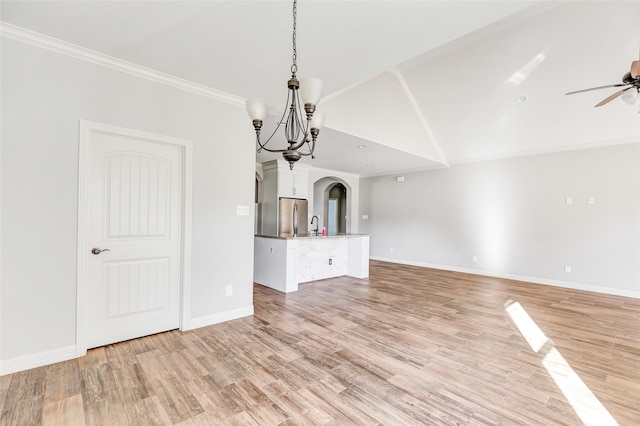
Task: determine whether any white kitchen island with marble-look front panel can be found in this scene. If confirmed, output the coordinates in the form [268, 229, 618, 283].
[253, 234, 369, 293]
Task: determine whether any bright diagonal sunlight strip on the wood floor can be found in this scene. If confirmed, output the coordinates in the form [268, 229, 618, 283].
[505, 300, 618, 426]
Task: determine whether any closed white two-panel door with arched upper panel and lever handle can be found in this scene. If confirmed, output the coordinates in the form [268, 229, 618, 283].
[80, 125, 184, 348]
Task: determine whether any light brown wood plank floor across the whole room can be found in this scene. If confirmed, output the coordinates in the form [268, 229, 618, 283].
[0, 262, 640, 425]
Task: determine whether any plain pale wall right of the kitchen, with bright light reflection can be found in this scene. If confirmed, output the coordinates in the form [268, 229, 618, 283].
[360, 143, 640, 297]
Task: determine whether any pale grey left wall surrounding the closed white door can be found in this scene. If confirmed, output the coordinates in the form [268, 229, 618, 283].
[0, 38, 255, 371]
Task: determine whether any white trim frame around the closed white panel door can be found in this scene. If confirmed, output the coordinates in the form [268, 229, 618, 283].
[76, 120, 193, 357]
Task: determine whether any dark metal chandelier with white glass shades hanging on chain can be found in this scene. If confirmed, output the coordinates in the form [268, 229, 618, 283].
[246, 0, 324, 170]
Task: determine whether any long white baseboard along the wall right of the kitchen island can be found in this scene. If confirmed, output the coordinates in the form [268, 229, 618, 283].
[370, 256, 640, 299]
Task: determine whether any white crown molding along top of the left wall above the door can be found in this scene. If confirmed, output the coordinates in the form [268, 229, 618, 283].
[0, 21, 244, 106]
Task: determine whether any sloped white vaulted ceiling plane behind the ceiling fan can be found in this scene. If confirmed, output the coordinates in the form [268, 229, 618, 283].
[398, 2, 640, 164]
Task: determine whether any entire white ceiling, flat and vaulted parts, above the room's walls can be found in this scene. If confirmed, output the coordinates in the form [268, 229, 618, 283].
[1, 0, 640, 176]
